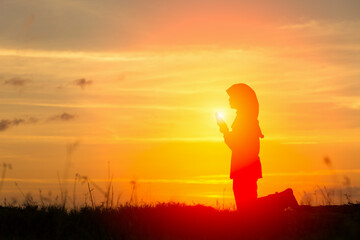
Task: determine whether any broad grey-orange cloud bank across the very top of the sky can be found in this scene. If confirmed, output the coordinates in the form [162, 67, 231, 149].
[0, 0, 360, 51]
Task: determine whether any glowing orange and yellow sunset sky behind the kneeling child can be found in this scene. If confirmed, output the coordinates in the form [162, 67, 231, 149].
[0, 0, 360, 205]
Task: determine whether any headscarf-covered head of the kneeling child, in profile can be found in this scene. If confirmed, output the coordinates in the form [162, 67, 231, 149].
[226, 83, 259, 118]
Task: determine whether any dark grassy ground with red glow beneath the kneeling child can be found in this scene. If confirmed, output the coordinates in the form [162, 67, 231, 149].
[0, 204, 360, 240]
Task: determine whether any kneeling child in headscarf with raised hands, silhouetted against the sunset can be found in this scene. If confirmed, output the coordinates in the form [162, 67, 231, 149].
[217, 83, 297, 209]
